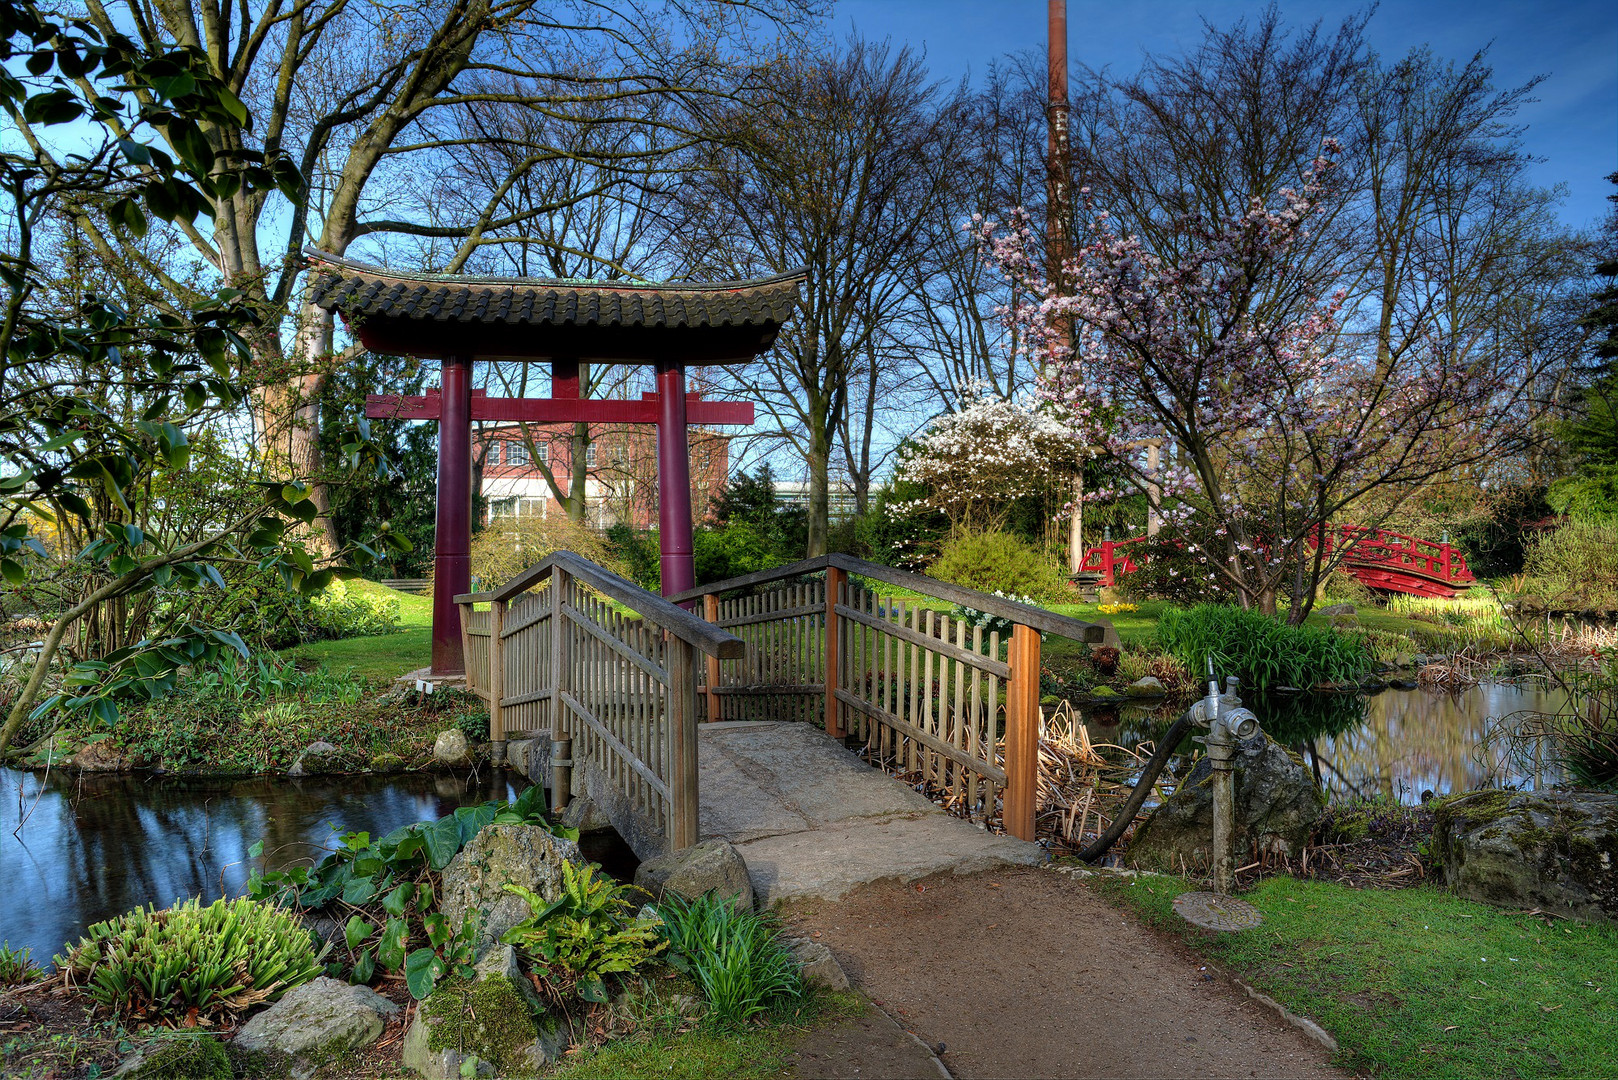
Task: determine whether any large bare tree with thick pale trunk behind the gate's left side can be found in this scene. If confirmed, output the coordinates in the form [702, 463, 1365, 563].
[42, 0, 799, 551]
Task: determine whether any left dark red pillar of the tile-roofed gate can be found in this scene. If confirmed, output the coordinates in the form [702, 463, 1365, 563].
[432, 356, 472, 675]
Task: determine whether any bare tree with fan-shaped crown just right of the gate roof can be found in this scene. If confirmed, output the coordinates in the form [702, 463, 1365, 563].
[683, 39, 959, 555]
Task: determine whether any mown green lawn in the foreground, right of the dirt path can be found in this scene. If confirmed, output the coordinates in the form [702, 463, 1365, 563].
[1097, 878, 1618, 1077]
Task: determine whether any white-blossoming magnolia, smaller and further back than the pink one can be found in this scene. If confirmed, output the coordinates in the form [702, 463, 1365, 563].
[890, 384, 1081, 531]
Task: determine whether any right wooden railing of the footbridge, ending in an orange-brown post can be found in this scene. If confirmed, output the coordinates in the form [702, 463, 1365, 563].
[670, 555, 1102, 840]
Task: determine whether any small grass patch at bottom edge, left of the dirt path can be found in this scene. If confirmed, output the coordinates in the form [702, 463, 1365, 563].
[545, 991, 869, 1080]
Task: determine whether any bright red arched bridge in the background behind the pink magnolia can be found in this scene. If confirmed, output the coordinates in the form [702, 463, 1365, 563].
[1079, 525, 1477, 599]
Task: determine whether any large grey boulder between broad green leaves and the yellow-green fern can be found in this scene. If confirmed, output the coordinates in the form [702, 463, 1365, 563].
[438, 824, 584, 957]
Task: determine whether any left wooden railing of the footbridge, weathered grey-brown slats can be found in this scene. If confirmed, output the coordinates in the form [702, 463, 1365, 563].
[455, 551, 746, 850]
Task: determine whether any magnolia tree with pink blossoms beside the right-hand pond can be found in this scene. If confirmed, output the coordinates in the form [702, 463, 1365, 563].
[974, 146, 1537, 622]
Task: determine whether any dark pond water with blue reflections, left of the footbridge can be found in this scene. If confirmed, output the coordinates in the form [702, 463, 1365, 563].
[0, 769, 519, 962]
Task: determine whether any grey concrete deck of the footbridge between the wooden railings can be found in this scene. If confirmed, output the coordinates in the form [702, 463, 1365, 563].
[697, 721, 1045, 905]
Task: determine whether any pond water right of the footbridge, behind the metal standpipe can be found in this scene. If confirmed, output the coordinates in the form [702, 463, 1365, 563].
[1081, 683, 1565, 803]
